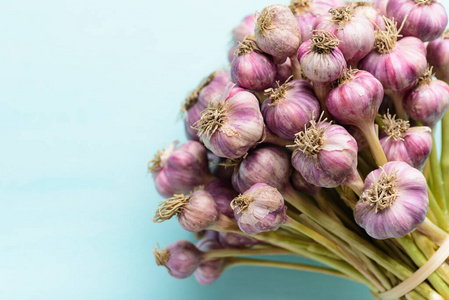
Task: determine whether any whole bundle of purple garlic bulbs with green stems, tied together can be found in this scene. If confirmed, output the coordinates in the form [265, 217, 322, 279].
[149, 0, 449, 299]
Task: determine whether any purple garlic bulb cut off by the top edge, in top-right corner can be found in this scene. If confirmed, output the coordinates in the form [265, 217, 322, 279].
[387, 0, 447, 42]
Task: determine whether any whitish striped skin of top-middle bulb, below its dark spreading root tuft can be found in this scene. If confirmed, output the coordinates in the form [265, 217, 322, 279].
[297, 35, 346, 83]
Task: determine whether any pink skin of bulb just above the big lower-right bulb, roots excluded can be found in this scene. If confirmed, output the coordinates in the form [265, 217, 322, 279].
[380, 126, 432, 170]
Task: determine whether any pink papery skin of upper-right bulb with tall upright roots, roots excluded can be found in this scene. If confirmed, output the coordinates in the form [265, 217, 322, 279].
[358, 37, 427, 92]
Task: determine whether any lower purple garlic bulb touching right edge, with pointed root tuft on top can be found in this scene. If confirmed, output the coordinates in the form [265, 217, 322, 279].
[403, 67, 449, 128]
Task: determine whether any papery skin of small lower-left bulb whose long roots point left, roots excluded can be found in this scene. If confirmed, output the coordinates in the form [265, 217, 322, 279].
[178, 190, 219, 232]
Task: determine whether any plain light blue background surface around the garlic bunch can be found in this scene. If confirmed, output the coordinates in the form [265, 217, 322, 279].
[0, 0, 447, 300]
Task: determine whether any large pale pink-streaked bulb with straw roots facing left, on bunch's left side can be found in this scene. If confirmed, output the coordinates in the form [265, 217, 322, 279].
[192, 83, 264, 157]
